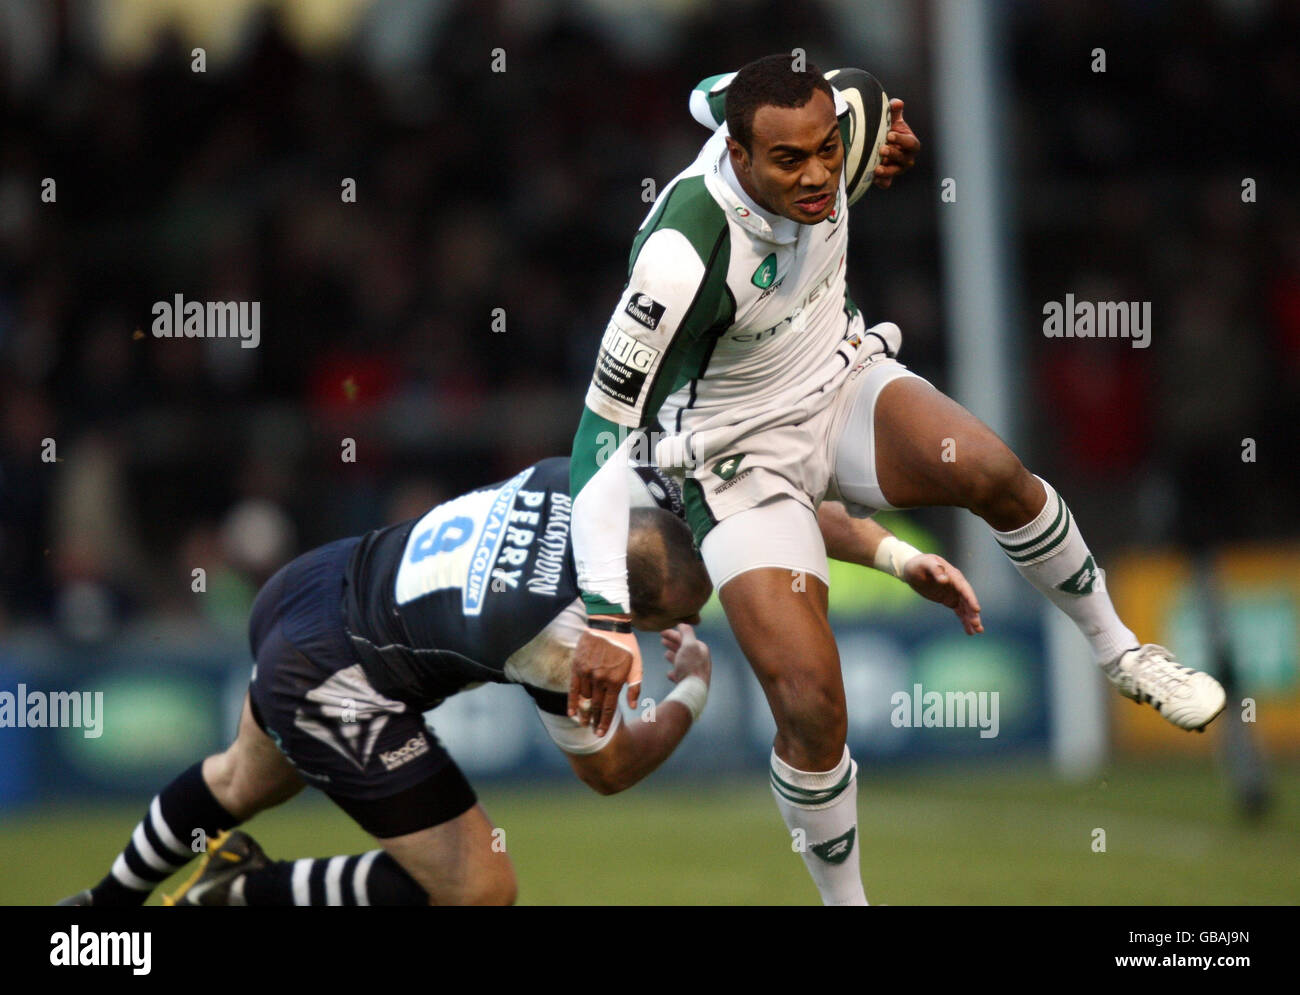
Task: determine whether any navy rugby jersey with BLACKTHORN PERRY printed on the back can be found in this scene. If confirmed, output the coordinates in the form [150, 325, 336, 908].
[343, 457, 683, 714]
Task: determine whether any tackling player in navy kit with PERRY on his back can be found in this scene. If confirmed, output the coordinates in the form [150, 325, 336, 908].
[60, 458, 980, 905]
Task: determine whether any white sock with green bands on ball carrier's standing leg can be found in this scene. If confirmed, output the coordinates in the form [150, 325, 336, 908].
[770, 747, 867, 905]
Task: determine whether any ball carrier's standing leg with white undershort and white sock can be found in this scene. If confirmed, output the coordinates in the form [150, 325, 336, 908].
[702, 498, 867, 905]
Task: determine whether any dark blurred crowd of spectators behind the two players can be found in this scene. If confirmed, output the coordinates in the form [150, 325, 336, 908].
[0, 1, 1300, 641]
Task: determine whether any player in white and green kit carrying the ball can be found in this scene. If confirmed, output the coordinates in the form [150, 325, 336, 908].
[569, 55, 1226, 904]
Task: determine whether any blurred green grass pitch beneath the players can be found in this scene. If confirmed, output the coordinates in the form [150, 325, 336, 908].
[0, 761, 1300, 905]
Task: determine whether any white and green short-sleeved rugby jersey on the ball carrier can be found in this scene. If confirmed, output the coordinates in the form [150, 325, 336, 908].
[586, 77, 875, 433]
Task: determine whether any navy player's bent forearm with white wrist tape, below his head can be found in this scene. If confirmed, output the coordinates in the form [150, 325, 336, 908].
[569, 624, 712, 795]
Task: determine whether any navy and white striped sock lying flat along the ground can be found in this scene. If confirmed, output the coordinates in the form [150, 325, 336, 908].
[230, 849, 429, 905]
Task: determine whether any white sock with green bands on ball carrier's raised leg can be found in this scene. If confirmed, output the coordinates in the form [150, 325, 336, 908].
[993, 477, 1138, 663]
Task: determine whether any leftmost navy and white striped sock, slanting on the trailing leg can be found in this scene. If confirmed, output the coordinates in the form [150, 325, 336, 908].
[90, 761, 239, 905]
